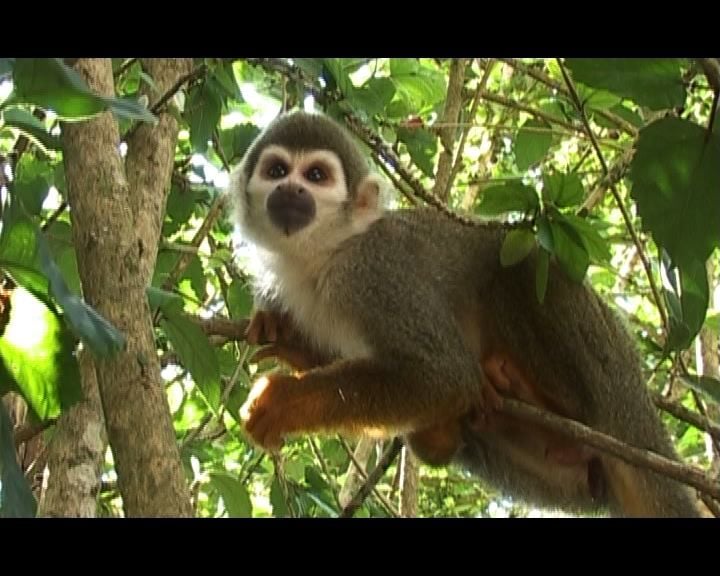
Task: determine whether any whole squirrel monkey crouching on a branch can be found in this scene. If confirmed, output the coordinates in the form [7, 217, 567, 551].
[229, 112, 699, 516]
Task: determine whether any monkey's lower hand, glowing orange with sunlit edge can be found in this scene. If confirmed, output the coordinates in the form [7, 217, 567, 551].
[240, 374, 298, 451]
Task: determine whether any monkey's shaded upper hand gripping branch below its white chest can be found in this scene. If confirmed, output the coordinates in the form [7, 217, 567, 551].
[246, 311, 329, 372]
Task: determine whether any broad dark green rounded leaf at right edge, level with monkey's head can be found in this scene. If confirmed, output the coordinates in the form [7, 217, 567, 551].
[630, 118, 720, 268]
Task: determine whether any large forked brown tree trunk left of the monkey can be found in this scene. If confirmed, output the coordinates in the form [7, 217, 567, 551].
[62, 59, 192, 516]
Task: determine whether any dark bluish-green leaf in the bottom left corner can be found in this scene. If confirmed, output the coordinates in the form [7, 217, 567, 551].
[0, 402, 37, 518]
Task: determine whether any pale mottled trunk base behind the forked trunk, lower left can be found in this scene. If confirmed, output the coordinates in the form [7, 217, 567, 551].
[38, 350, 107, 518]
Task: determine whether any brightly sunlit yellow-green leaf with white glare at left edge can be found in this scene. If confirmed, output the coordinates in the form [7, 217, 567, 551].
[0, 286, 81, 420]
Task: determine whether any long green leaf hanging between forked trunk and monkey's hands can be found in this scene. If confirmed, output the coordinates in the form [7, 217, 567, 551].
[160, 309, 221, 410]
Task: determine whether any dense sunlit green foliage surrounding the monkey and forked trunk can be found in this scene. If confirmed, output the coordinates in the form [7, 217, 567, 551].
[0, 59, 720, 516]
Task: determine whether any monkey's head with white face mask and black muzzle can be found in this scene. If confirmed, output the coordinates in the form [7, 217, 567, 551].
[229, 112, 382, 264]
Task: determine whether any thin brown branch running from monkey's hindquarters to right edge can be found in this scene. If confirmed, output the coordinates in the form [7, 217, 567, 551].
[502, 399, 720, 498]
